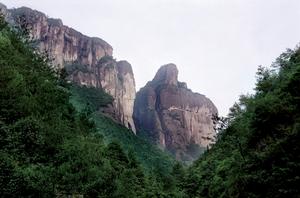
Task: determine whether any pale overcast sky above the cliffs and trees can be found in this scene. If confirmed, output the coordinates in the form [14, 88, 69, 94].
[0, 0, 300, 115]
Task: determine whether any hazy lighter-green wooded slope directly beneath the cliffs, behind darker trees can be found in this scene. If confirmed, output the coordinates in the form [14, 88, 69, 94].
[70, 85, 175, 175]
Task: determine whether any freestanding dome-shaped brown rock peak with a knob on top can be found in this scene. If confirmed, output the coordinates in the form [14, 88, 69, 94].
[134, 64, 217, 161]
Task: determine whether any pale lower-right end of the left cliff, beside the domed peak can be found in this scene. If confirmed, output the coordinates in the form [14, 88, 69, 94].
[70, 56, 136, 133]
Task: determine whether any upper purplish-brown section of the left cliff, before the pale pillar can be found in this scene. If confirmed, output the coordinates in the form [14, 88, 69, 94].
[9, 7, 113, 67]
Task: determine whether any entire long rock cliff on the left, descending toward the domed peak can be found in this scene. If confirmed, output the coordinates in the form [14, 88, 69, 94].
[0, 4, 135, 132]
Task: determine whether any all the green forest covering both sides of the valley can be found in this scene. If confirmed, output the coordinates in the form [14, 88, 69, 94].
[0, 13, 300, 198]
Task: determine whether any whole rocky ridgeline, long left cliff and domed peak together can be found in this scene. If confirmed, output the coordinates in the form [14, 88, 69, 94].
[0, 2, 217, 161]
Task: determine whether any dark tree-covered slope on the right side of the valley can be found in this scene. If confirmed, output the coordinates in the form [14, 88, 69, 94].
[184, 48, 300, 198]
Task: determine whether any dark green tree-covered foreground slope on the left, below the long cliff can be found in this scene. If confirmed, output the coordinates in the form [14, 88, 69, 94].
[0, 18, 177, 197]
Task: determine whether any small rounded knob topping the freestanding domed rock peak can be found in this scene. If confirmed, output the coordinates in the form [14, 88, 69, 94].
[152, 63, 178, 85]
